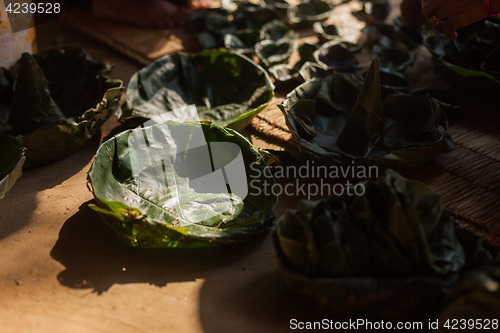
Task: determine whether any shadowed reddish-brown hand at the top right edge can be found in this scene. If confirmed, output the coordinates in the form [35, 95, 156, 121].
[422, 0, 488, 39]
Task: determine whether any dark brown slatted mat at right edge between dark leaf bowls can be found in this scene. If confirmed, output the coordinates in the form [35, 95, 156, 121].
[405, 113, 500, 247]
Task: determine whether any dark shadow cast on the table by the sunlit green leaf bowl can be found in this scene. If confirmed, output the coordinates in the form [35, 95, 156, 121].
[50, 201, 268, 293]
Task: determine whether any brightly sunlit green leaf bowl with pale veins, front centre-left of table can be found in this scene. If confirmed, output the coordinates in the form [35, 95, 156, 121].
[88, 121, 277, 248]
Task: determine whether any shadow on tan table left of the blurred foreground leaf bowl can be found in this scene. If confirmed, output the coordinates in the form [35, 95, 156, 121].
[199, 179, 323, 333]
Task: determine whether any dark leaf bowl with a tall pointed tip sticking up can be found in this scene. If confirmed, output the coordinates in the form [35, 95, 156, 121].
[278, 60, 453, 168]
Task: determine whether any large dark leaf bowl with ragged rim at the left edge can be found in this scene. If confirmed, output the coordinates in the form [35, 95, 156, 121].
[0, 48, 123, 168]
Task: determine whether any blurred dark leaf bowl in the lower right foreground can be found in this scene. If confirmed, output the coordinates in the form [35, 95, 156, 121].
[274, 170, 489, 320]
